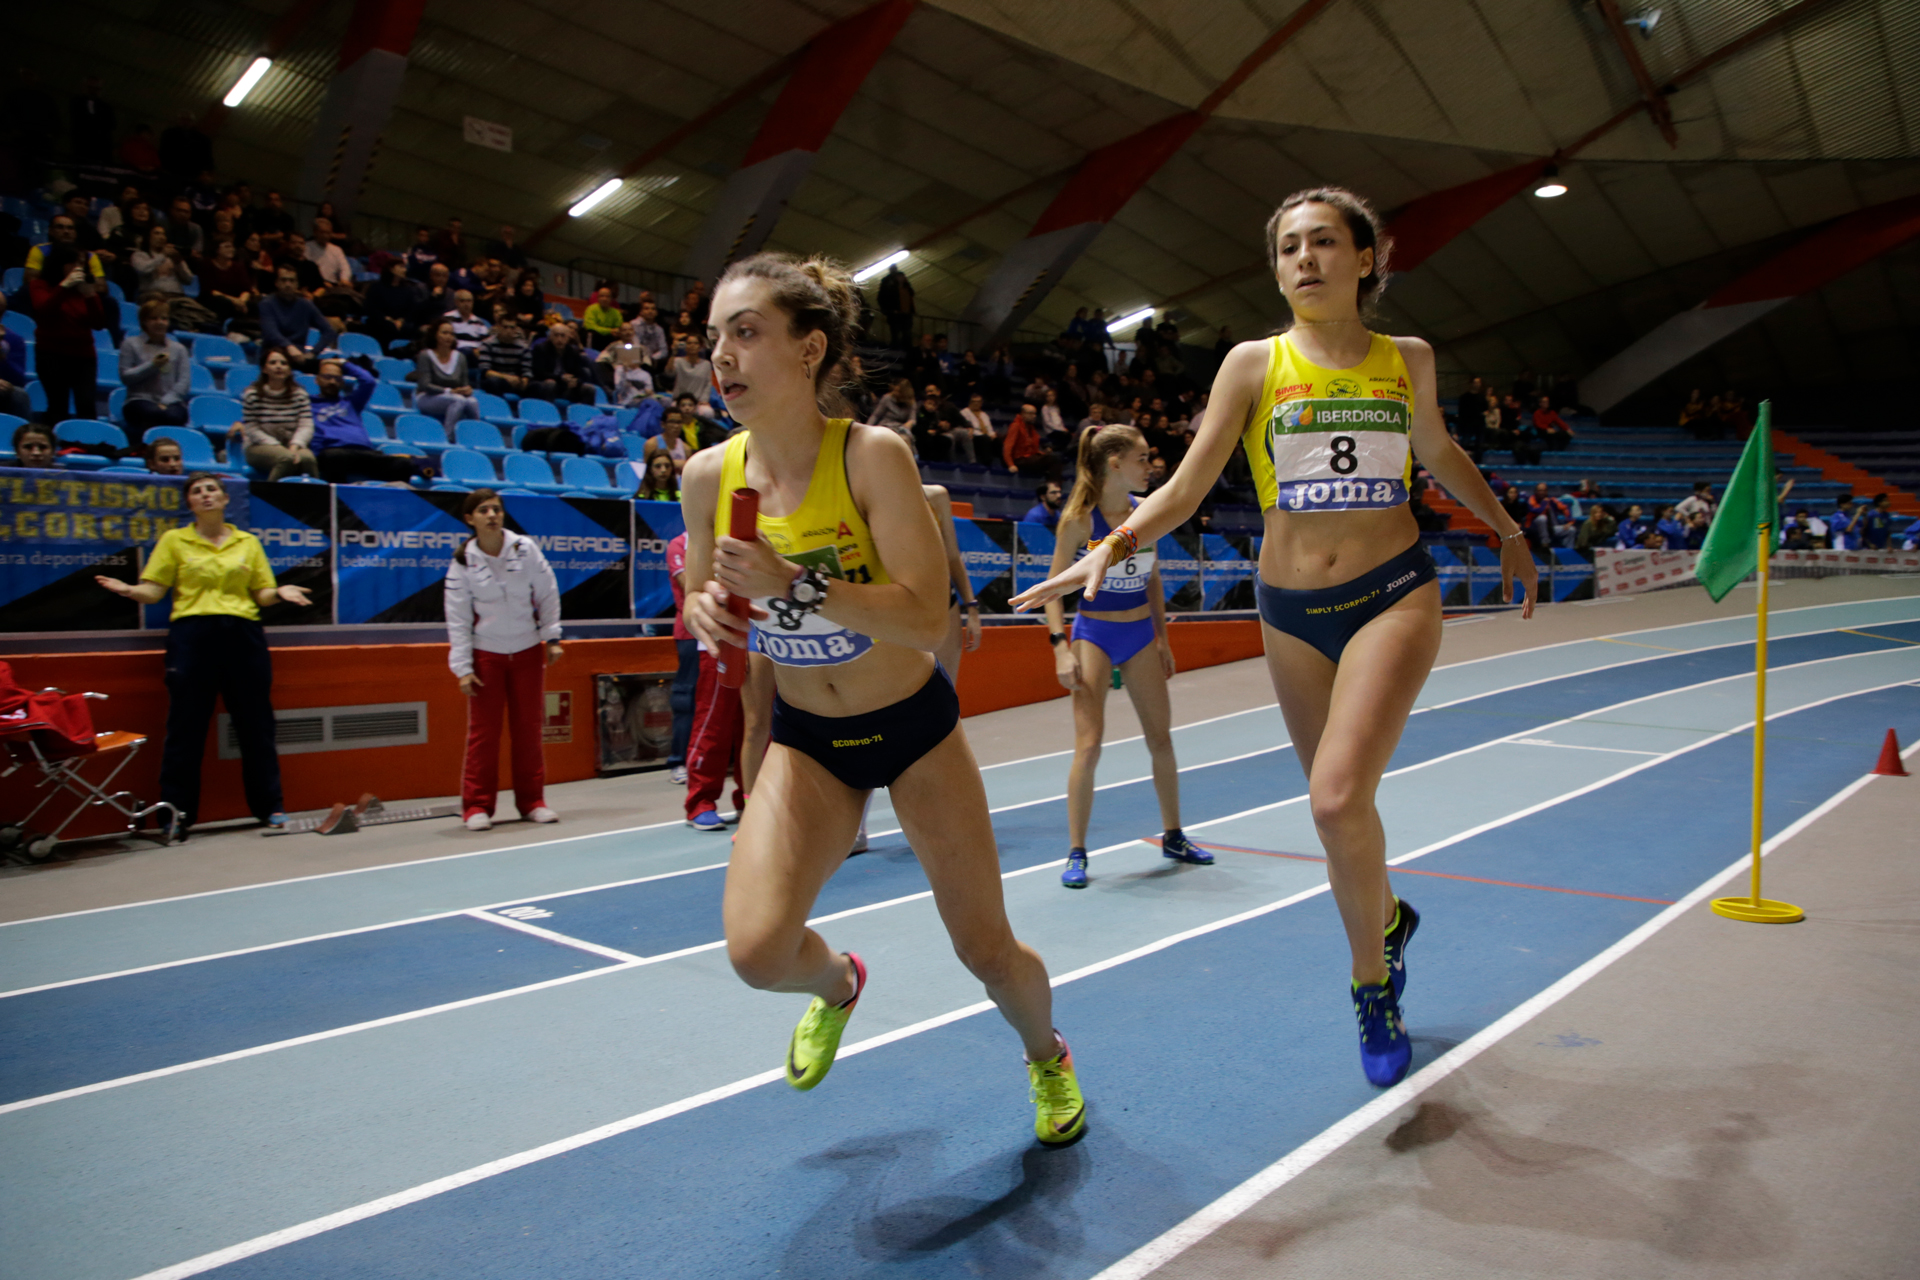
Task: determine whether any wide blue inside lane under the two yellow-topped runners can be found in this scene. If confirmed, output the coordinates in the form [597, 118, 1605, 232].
[191, 685, 1920, 1280]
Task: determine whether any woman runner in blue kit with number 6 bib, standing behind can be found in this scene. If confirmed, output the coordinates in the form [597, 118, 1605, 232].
[1046, 426, 1190, 889]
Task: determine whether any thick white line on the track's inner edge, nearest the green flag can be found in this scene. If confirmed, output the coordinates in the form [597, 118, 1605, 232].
[1082, 752, 1904, 1280]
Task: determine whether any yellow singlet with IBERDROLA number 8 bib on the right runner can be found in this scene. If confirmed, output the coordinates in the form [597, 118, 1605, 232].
[1240, 334, 1413, 512]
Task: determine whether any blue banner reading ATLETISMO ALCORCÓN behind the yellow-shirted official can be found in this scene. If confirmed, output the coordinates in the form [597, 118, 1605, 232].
[0, 470, 210, 631]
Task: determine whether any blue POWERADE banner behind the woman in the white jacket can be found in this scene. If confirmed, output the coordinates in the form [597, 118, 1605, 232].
[334, 486, 634, 624]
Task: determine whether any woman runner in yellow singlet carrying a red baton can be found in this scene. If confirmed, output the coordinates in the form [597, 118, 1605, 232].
[682, 253, 1087, 1144]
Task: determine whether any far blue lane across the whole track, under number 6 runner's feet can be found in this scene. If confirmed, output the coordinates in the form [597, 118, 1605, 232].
[0, 622, 1920, 1103]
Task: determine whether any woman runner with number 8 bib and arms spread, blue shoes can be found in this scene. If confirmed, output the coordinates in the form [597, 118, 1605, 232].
[1014, 186, 1538, 1086]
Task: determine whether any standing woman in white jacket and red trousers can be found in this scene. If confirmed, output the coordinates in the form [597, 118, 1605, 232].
[445, 489, 561, 831]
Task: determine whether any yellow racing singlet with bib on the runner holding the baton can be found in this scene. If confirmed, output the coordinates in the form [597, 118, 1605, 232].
[714, 418, 891, 666]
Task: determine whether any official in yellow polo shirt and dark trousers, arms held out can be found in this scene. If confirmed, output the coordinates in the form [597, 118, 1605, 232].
[94, 472, 313, 839]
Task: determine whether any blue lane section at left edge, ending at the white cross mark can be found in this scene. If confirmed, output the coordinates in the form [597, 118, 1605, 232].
[0, 915, 614, 1103]
